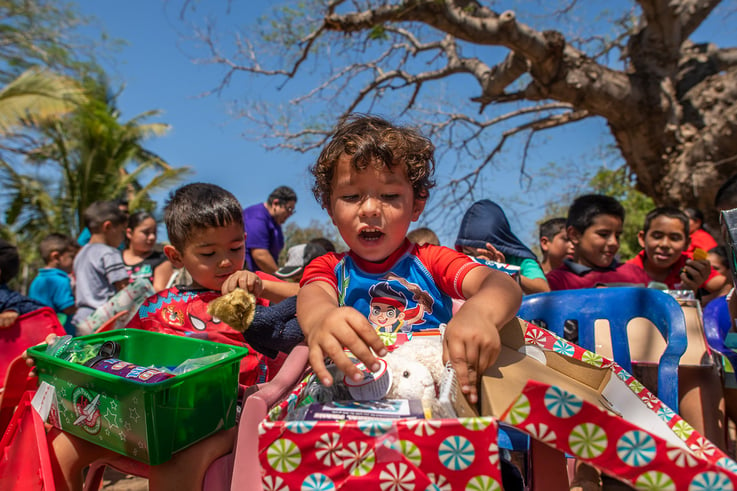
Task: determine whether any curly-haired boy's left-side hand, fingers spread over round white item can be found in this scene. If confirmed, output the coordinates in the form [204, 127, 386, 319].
[303, 307, 387, 386]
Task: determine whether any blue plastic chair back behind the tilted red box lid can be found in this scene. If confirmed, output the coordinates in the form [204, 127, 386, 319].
[517, 287, 688, 412]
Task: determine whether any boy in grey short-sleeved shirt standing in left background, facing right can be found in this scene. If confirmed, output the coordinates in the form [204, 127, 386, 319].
[72, 201, 129, 334]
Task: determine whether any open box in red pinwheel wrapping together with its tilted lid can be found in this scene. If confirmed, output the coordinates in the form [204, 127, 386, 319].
[252, 319, 737, 491]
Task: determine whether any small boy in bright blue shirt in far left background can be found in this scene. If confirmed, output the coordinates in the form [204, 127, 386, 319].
[28, 233, 77, 335]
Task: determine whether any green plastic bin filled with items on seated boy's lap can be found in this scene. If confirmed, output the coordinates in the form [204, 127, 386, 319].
[28, 329, 248, 465]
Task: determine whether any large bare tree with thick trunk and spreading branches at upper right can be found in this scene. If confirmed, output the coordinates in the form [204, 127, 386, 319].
[178, 0, 737, 230]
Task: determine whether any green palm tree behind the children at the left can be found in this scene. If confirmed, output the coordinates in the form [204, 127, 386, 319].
[0, 79, 189, 282]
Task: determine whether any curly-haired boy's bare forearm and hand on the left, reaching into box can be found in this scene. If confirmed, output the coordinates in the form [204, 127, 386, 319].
[297, 281, 386, 385]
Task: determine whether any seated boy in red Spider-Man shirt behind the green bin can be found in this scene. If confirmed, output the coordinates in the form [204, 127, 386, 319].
[50, 183, 304, 490]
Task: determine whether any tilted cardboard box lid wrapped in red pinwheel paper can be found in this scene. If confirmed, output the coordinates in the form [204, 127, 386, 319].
[481, 319, 737, 491]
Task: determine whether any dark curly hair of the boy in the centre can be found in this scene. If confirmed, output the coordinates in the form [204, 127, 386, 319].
[310, 114, 435, 209]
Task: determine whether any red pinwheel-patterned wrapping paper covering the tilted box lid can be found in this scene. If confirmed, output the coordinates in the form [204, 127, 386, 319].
[508, 324, 737, 491]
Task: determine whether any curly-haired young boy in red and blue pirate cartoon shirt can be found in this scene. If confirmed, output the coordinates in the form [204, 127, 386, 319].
[297, 115, 522, 403]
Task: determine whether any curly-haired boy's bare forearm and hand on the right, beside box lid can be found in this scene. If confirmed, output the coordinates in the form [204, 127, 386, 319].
[443, 268, 522, 404]
